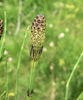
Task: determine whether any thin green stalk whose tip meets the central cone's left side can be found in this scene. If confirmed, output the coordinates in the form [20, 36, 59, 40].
[15, 27, 29, 100]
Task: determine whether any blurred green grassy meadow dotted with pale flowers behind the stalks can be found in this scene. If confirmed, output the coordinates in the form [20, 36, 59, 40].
[0, 0, 83, 100]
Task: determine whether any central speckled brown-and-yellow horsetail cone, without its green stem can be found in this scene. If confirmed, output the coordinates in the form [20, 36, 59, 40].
[30, 14, 45, 61]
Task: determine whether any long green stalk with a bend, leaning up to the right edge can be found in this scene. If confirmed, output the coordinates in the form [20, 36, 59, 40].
[65, 52, 83, 100]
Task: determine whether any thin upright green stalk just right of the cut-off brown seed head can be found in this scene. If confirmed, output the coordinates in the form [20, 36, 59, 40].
[0, 11, 7, 58]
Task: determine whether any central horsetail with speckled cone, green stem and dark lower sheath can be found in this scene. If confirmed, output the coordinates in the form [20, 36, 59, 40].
[27, 14, 45, 96]
